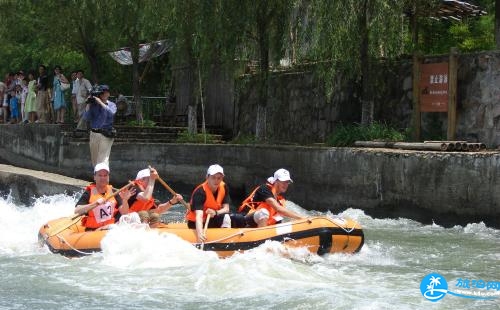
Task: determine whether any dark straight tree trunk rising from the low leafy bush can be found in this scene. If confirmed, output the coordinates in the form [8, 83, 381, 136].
[359, 0, 374, 125]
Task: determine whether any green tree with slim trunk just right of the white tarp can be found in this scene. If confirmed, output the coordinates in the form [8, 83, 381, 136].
[167, 0, 244, 134]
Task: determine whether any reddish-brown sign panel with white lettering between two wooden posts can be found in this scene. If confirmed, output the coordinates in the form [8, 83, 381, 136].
[420, 62, 448, 112]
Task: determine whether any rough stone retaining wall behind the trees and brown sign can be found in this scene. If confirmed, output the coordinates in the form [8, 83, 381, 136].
[235, 51, 500, 148]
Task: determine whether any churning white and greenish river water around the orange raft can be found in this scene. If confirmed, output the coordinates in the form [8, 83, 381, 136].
[0, 195, 500, 310]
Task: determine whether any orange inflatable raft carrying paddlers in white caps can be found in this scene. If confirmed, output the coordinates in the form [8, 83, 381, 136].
[38, 216, 364, 257]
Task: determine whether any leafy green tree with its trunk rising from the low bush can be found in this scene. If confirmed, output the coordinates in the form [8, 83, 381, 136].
[308, 0, 412, 125]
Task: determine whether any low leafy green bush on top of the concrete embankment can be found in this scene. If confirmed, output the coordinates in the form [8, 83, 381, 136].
[326, 122, 406, 146]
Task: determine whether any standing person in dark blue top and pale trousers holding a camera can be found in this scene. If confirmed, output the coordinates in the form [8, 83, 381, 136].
[83, 85, 116, 166]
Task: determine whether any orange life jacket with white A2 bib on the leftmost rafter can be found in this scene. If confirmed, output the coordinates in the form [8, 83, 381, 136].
[82, 184, 118, 228]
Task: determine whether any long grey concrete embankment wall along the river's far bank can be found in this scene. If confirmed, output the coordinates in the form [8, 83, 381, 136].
[0, 125, 500, 227]
